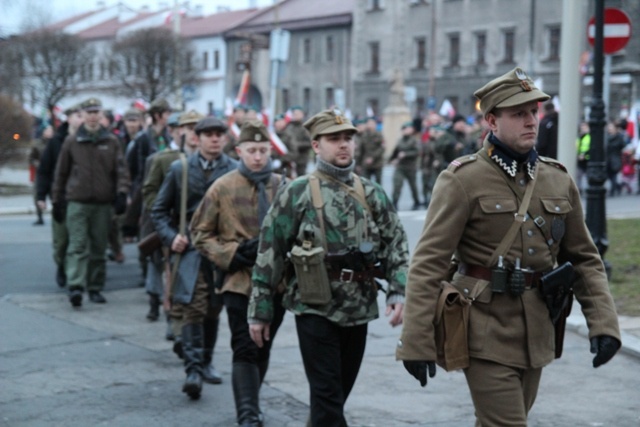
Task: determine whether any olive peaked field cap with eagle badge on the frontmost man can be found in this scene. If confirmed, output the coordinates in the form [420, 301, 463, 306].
[473, 67, 550, 116]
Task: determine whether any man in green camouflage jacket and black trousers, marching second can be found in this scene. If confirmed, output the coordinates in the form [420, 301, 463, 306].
[248, 110, 408, 427]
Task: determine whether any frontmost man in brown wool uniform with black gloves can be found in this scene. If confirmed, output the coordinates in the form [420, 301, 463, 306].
[396, 68, 621, 427]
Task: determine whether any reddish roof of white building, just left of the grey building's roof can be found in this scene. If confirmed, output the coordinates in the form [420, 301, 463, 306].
[170, 8, 260, 38]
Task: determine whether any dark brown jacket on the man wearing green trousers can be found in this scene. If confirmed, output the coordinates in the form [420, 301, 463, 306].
[51, 125, 130, 203]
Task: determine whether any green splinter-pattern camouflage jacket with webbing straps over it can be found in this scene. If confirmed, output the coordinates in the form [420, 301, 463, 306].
[248, 172, 409, 326]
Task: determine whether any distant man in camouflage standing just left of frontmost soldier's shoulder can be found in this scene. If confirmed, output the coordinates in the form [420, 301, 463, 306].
[389, 122, 420, 210]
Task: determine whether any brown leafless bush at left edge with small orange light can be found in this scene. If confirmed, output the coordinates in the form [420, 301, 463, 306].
[0, 95, 33, 166]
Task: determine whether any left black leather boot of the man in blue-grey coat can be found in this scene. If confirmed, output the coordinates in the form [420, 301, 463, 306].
[182, 323, 203, 400]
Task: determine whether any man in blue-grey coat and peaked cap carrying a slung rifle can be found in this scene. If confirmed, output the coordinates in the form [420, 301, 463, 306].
[151, 117, 237, 399]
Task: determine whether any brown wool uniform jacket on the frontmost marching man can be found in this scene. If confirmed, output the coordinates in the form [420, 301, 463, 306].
[396, 148, 620, 368]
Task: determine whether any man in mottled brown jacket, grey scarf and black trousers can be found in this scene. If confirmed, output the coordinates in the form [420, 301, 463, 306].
[191, 120, 285, 427]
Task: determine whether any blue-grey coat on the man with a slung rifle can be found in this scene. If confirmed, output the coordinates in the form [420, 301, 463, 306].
[151, 153, 238, 304]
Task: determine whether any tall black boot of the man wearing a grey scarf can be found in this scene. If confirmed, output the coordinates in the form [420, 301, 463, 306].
[231, 362, 262, 427]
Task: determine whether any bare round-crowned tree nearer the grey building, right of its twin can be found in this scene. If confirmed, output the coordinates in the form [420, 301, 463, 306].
[110, 27, 199, 101]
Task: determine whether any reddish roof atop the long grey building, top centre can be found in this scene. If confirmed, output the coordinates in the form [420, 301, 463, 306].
[228, 0, 356, 32]
